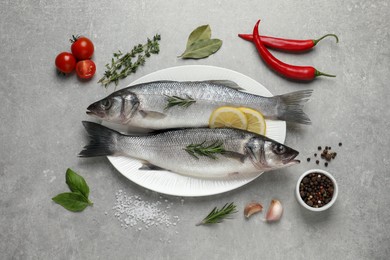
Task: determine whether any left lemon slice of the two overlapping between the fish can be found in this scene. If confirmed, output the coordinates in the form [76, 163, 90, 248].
[209, 106, 248, 130]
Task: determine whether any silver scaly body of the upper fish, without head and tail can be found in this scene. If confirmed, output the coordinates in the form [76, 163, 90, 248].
[127, 82, 277, 129]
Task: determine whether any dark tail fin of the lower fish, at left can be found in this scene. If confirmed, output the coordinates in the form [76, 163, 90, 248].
[78, 121, 121, 157]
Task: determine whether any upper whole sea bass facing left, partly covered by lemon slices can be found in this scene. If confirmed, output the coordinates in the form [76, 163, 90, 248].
[87, 81, 312, 130]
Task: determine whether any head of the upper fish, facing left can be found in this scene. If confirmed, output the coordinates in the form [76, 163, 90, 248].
[87, 92, 139, 124]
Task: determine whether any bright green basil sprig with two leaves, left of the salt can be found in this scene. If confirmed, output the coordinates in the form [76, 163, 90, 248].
[52, 169, 93, 212]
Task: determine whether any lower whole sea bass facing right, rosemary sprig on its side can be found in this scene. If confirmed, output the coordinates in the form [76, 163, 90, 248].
[79, 122, 299, 179]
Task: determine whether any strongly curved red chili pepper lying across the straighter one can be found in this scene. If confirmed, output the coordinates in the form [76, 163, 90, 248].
[253, 20, 336, 80]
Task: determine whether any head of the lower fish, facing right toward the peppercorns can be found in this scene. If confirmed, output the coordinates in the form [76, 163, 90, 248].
[245, 137, 300, 170]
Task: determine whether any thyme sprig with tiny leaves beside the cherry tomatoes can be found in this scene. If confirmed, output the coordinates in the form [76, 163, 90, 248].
[98, 34, 161, 88]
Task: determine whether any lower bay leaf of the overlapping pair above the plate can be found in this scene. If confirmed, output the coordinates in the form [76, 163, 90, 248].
[181, 39, 222, 59]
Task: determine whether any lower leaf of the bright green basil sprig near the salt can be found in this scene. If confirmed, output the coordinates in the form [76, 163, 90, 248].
[52, 192, 92, 212]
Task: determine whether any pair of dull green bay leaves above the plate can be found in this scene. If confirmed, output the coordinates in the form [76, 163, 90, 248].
[179, 25, 222, 59]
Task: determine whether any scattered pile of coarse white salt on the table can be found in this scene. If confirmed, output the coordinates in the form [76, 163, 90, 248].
[112, 190, 183, 231]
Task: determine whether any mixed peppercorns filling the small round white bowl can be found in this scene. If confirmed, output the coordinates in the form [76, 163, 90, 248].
[299, 172, 334, 208]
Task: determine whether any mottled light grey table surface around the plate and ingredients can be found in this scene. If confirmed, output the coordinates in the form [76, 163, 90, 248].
[0, 0, 390, 259]
